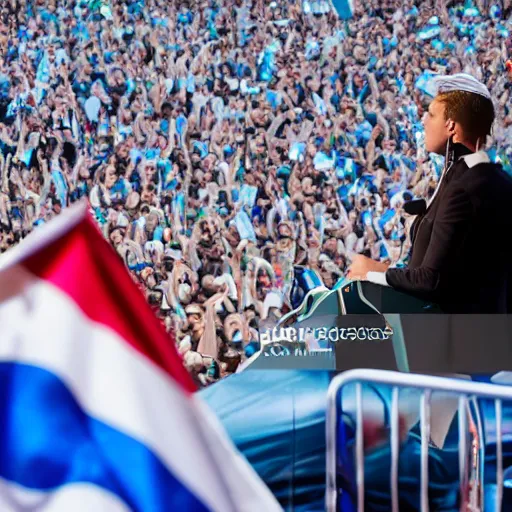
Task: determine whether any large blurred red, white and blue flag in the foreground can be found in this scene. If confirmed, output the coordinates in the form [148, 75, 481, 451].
[0, 204, 281, 512]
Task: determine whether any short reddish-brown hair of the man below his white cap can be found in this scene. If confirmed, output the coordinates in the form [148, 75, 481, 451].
[436, 91, 494, 141]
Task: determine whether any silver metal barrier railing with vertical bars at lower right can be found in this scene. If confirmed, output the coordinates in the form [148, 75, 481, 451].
[326, 369, 512, 512]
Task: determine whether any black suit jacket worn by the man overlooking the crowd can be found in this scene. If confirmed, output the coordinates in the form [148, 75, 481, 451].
[386, 145, 512, 314]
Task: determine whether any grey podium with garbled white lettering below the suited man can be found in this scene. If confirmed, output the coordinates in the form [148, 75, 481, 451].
[248, 281, 512, 374]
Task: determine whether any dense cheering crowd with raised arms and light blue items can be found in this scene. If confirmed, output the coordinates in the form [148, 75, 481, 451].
[0, 0, 512, 385]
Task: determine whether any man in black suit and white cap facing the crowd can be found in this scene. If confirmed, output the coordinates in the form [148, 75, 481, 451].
[348, 74, 512, 314]
